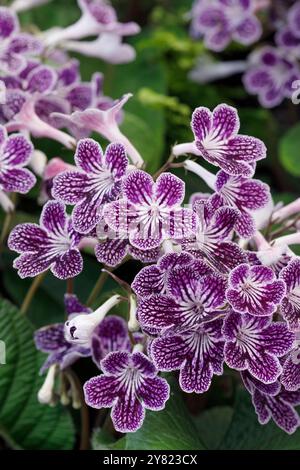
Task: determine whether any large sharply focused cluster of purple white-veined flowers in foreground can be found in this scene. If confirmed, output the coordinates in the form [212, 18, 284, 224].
[8, 104, 300, 433]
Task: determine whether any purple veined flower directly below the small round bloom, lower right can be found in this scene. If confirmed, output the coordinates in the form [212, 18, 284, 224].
[223, 312, 295, 384]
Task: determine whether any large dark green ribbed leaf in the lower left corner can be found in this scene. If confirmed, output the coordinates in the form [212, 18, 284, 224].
[0, 299, 74, 450]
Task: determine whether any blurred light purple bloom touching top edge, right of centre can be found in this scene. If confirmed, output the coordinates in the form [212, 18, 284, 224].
[191, 0, 262, 51]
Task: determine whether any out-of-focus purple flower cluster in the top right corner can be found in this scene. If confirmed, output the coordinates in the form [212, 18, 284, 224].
[191, 0, 300, 108]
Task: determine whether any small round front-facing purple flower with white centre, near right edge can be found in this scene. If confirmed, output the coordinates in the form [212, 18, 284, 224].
[226, 263, 286, 317]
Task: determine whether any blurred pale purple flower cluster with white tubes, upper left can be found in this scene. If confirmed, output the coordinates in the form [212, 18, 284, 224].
[0, 0, 143, 211]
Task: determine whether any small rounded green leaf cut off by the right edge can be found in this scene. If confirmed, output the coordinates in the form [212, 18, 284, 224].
[279, 124, 300, 176]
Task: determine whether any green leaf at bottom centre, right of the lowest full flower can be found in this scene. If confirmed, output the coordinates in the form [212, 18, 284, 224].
[125, 380, 204, 450]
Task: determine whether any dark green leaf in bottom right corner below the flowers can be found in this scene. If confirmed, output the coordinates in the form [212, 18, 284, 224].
[198, 390, 300, 450]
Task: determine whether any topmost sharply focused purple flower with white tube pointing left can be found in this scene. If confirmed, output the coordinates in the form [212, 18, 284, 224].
[173, 104, 266, 177]
